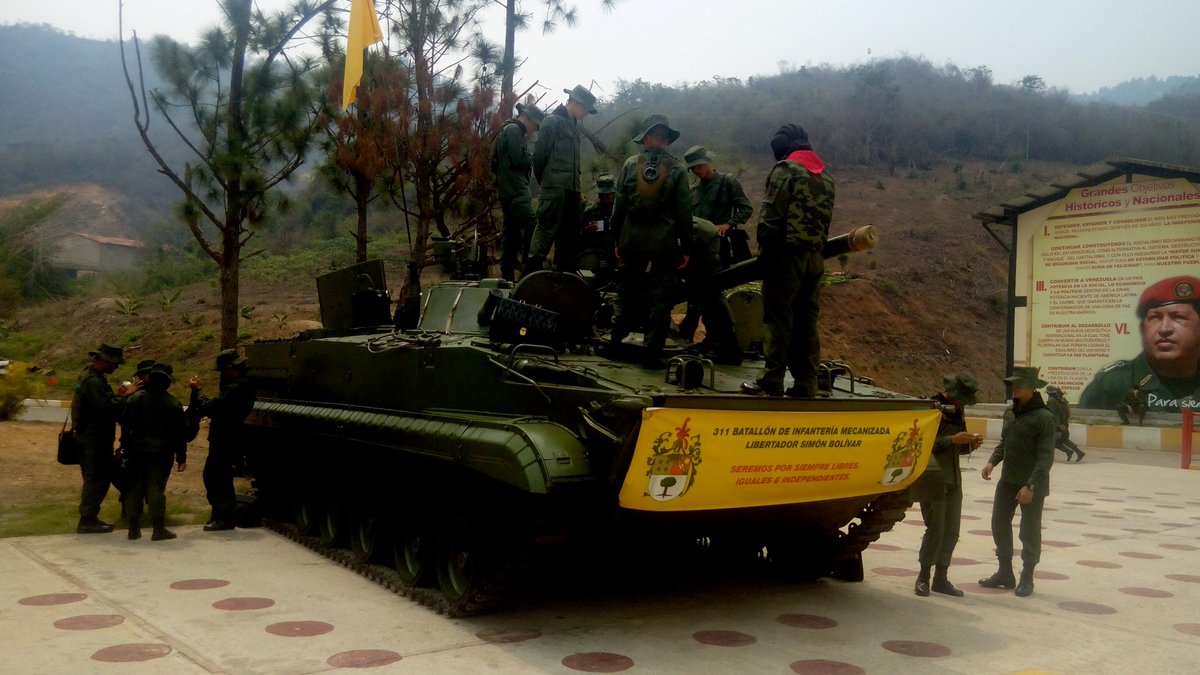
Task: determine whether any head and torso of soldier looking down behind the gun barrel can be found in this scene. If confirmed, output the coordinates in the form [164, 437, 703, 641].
[683, 145, 754, 267]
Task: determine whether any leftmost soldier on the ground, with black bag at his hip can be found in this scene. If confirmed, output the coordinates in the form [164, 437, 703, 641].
[71, 345, 138, 534]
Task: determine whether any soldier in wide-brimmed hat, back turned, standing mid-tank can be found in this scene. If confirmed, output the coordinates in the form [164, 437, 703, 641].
[610, 114, 692, 369]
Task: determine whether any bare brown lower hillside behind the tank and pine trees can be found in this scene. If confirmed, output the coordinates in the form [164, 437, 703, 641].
[0, 157, 1070, 401]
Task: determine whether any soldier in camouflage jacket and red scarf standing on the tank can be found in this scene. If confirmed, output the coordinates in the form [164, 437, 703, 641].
[742, 124, 834, 398]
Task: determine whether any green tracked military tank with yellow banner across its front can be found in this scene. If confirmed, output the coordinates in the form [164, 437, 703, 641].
[247, 228, 940, 616]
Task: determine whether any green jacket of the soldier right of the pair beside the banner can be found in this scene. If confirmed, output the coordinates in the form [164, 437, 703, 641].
[988, 392, 1058, 496]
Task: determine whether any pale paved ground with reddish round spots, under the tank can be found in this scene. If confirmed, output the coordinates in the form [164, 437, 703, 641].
[0, 449, 1200, 674]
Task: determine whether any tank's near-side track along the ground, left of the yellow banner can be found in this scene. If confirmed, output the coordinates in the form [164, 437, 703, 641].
[263, 520, 528, 619]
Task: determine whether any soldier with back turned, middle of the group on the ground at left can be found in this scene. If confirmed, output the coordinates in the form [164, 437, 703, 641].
[121, 363, 191, 542]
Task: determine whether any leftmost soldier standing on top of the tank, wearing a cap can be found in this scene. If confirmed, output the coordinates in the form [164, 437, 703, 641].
[492, 103, 546, 281]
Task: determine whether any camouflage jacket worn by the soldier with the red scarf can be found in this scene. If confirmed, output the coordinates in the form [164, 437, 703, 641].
[758, 152, 834, 251]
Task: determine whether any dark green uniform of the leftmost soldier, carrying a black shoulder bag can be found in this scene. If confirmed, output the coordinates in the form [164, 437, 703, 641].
[71, 365, 125, 519]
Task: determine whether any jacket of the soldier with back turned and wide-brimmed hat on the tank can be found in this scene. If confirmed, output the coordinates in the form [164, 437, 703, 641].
[612, 150, 691, 257]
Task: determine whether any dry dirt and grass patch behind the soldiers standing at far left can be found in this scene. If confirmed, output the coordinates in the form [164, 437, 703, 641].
[0, 422, 216, 536]
